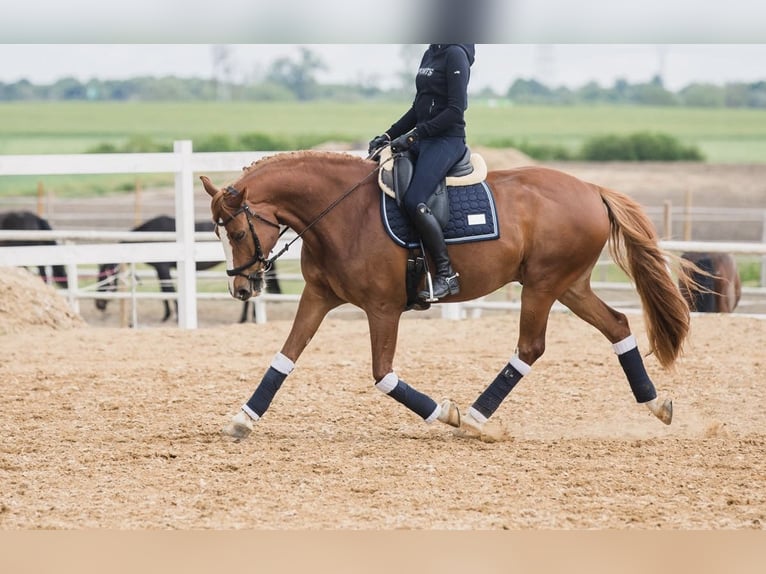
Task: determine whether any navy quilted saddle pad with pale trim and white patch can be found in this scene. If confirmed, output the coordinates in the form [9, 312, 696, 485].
[380, 182, 500, 249]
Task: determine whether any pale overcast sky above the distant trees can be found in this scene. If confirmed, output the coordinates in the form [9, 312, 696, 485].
[0, 44, 766, 93]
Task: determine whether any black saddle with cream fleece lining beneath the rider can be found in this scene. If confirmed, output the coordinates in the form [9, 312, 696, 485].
[378, 146, 487, 229]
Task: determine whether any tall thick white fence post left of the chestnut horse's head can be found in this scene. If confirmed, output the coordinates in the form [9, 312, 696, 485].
[173, 140, 197, 329]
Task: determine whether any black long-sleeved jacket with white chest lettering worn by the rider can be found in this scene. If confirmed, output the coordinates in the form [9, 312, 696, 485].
[387, 44, 475, 139]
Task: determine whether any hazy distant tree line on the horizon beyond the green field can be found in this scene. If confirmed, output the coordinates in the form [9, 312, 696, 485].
[0, 48, 766, 108]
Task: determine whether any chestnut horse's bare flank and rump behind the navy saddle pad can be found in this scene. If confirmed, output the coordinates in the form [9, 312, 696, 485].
[450, 167, 609, 299]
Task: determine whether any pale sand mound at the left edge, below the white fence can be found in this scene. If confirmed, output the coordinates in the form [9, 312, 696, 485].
[0, 267, 85, 335]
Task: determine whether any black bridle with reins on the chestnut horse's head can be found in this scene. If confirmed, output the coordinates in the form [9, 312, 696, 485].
[216, 153, 391, 283]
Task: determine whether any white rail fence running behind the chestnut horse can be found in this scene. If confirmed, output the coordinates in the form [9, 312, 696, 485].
[0, 141, 766, 329]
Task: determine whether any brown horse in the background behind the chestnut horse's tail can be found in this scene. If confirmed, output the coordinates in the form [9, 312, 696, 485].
[679, 251, 742, 313]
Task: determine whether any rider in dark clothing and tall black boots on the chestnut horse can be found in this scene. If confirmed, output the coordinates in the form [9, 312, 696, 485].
[369, 44, 475, 299]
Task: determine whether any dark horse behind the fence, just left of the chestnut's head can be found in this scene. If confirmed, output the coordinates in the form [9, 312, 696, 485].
[96, 215, 282, 323]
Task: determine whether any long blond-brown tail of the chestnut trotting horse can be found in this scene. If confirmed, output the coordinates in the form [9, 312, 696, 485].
[599, 188, 689, 368]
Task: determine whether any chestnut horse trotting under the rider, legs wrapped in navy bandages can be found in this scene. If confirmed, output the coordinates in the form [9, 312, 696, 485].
[200, 151, 690, 442]
